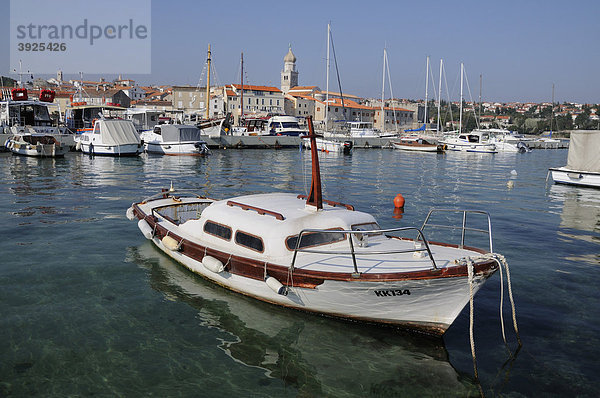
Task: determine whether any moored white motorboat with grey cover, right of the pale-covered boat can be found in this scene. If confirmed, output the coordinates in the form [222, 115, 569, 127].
[140, 124, 210, 156]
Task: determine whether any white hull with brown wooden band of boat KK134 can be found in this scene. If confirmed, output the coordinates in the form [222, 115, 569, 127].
[132, 205, 497, 335]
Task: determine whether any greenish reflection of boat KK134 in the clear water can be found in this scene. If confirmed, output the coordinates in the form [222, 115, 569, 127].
[128, 242, 478, 397]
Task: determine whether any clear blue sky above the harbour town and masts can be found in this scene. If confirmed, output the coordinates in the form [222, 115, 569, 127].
[0, 0, 600, 103]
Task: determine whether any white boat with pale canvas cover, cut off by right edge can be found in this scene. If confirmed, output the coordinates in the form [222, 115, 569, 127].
[549, 130, 600, 188]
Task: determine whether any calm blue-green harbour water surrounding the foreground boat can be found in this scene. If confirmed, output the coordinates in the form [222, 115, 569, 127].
[0, 150, 600, 397]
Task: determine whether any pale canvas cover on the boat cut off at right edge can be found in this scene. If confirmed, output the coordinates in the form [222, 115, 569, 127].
[567, 130, 600, 173]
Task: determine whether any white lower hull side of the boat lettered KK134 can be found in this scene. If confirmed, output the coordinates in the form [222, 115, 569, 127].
[146, 232, 489, 335]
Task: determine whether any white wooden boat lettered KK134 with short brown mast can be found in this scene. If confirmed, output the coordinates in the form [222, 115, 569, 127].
[127, 118, 499, 334]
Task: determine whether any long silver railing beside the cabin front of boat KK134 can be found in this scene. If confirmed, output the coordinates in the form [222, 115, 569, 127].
[290, 227, 438, 278]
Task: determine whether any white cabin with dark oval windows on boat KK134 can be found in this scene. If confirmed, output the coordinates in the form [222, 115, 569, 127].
[158, 193, 379, 261]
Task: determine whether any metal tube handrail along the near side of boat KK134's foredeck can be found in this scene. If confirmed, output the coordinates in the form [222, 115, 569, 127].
[290, 227, 438, 278]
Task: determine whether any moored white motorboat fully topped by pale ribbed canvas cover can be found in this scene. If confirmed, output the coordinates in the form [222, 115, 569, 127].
[76, 119, 142, 156]
